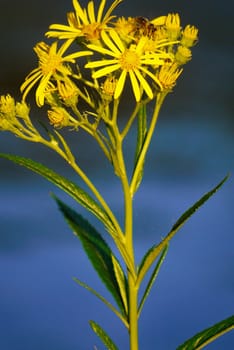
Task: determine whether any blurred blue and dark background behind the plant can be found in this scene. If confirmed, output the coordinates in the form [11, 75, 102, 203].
[0, 0, 234, 350]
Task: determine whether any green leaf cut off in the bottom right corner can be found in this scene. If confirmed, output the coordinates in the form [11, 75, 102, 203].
[177, 316, 234, 350]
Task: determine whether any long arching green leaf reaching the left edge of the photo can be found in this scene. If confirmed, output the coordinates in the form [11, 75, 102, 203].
[0, 154, 115, 233]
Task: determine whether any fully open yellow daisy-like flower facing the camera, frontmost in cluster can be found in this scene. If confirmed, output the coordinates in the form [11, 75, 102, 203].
[85, 30, 170, 102]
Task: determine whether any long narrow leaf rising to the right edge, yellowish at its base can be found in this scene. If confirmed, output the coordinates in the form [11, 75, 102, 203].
[137, 176, 228, 285]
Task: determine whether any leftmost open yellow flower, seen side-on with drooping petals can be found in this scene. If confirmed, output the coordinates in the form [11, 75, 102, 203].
[20, 40, 92, 107]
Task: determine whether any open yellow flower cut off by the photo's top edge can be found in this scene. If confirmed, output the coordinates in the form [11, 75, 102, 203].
[46, 0, 122, 41]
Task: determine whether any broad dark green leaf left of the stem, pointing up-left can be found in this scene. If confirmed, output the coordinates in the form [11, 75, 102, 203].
[54, 196, 128, 315]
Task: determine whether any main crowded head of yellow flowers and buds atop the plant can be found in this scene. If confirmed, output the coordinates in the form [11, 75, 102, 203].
[1, 0, 198, 133]
